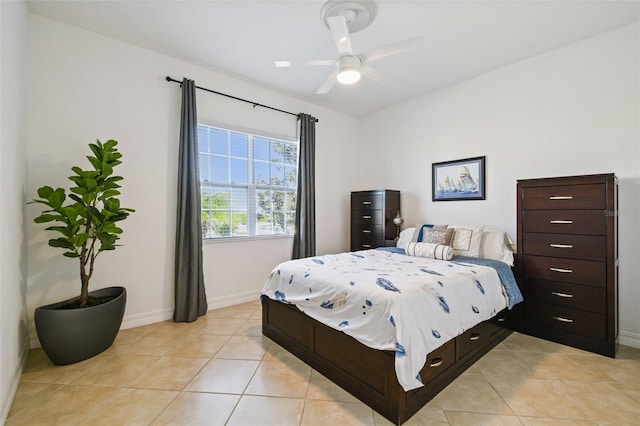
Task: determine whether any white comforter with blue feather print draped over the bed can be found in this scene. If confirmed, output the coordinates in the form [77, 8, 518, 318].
[262, 250, 507, 391]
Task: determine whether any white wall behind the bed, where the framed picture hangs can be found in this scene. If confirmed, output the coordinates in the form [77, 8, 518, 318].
[358, 24, 640, 347]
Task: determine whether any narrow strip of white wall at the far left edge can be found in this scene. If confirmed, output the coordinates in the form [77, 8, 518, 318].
[0, 1, 29, 421]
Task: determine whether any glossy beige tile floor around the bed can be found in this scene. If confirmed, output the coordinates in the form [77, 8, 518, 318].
[6, 302, 640, 426]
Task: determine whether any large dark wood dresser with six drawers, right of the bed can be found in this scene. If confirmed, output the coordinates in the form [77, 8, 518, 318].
[517, 174, 618, 357]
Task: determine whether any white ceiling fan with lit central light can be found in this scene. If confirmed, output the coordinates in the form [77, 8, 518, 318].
[276, 0, 423, 95]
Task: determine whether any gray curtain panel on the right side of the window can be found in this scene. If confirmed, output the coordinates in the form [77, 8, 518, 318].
[291, 114, 316, 259]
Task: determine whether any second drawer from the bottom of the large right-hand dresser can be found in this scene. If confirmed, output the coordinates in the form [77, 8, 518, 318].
[523, 279, 607, 314]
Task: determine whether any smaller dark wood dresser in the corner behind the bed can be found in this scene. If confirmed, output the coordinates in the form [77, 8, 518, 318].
[351, 189, 400, 251]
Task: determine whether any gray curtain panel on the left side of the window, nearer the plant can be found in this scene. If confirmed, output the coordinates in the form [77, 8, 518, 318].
[173, 78, 207, 322]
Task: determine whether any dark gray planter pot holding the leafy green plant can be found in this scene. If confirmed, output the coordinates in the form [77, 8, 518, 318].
[34, 287, 127, 365]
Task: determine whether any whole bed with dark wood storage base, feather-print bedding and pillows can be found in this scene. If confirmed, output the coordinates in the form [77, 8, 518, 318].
[261, 225, 522, 424]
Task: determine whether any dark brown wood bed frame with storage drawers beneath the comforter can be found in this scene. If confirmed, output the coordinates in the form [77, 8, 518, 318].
[261, 295, 511, 425]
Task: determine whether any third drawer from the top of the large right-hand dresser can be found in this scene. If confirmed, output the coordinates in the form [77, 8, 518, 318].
[522, 232, 607, 261]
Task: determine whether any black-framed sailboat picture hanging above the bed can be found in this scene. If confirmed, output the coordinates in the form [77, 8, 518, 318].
[431, 156, 486, 201]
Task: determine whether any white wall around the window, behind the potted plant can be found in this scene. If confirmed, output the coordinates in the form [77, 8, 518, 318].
[27, 15, 358, 343]
